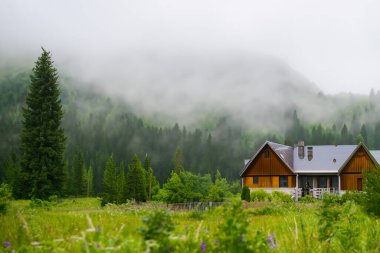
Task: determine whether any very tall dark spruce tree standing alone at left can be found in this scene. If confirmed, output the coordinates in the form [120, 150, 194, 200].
[20, 48, 65, 199]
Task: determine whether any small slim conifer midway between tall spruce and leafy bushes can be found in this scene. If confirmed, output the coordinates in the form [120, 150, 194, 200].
[102, 155, 117, 205]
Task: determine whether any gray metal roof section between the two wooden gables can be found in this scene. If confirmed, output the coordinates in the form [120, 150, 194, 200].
[293, 145, 358, 173]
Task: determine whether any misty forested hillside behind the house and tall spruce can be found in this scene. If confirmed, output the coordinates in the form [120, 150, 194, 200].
[0, 67, 380, 192]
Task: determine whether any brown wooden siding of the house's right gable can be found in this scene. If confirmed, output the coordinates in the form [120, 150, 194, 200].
[340, 147, 376, 190]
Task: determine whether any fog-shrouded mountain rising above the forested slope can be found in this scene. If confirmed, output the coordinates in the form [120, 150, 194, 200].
[58, 52, 372, 132]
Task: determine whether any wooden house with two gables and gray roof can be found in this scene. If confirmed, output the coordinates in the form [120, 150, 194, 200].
[240, 141, 380, 199]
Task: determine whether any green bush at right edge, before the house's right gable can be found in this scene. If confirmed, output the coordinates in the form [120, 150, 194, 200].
[364, 167, 380, 216]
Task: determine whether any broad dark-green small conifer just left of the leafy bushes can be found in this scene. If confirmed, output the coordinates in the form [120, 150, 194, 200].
[127, 155, 147, 202]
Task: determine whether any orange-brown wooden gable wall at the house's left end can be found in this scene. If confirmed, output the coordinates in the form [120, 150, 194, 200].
[243, 144, 296, 188]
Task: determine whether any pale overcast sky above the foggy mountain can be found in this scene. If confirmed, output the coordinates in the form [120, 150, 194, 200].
[0, 0, 380, 94]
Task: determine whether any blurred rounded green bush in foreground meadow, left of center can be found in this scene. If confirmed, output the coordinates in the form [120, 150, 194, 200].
[140, 210, 174, 252]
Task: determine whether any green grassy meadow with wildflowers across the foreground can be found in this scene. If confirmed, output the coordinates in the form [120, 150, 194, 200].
[0, 198, 380, 253]
